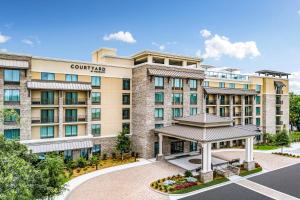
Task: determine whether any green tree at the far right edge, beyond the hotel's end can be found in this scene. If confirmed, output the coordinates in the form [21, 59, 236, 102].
[289, 93, 300, 131]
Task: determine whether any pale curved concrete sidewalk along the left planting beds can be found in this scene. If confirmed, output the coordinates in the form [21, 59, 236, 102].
[55, 158, 152, 200]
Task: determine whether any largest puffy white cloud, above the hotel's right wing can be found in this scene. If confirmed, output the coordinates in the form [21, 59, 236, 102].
[202, 29, 260, 59]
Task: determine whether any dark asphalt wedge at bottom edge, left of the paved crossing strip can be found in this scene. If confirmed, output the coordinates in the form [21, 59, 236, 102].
[181, 183, 272, 200]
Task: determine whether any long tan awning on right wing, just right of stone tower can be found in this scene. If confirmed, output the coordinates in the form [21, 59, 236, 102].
[204, 87, 257, 95]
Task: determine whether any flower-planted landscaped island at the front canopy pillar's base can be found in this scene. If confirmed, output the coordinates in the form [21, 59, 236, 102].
[150, 172, 229, 194]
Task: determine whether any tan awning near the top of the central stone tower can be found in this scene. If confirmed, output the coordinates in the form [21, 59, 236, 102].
[148, 68, 204, 79]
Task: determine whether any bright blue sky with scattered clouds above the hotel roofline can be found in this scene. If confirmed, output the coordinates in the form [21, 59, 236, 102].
[0, 0, 300, 76]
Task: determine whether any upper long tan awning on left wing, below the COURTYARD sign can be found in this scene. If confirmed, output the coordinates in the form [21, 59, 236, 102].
[27, 81, 92, 91]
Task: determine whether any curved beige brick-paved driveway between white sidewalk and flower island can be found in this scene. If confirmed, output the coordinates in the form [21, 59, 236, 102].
[67, 162, 184, 200]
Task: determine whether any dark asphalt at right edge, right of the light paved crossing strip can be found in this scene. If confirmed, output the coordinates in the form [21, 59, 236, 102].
[249, 164, 300, 198]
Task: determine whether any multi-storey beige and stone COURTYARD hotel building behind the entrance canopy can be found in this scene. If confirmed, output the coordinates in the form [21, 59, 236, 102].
[0, 48, 289, 158]
